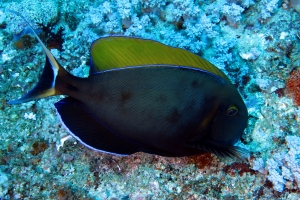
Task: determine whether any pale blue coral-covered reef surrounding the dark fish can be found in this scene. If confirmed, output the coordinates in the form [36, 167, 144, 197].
[0, 0, 300, 200]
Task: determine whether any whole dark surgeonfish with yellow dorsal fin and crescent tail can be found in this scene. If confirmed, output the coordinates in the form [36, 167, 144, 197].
[8, 11, 248, 158]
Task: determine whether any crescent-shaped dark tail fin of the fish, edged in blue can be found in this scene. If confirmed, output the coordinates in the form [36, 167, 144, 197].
[6, 9, 68, 104]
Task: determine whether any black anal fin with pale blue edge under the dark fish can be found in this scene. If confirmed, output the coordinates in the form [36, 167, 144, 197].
[55, 97, 138, 155]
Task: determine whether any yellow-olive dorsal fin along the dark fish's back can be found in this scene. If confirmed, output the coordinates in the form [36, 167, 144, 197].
[90, 36, 229, 80]
